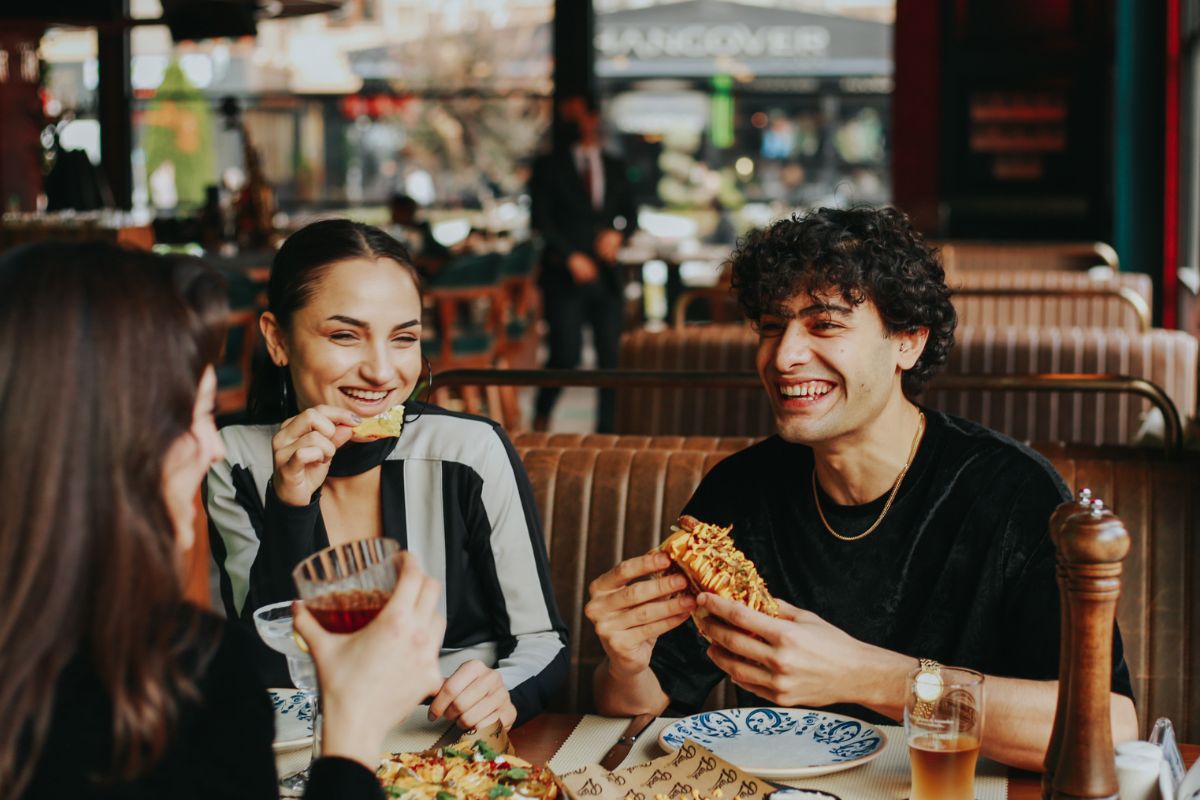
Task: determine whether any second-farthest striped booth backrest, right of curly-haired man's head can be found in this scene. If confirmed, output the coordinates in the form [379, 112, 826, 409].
[949, 270, 1153, 332]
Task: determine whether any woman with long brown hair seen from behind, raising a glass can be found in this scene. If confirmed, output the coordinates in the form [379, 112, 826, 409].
[0, 245, 440, 800]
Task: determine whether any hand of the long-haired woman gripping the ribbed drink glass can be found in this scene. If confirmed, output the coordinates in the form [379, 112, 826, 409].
[294, 554, 445, 770]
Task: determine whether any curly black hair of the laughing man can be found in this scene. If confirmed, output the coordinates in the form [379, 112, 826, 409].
[731, 207, 958, 397]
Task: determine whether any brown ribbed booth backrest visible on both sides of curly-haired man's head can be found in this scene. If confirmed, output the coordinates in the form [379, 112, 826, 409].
[616, 325, 1198, 444]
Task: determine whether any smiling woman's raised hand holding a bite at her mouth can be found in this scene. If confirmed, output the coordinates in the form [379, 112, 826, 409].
[271, 405, 362, 506]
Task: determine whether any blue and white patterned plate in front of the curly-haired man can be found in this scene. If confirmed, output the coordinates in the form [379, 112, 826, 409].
[659, 708, 888, 778]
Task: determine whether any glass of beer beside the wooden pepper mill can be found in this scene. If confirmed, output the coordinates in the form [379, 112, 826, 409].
[904, 667, 983, 800]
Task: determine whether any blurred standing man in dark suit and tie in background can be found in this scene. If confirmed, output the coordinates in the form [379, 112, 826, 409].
[529, 95, 637, 433]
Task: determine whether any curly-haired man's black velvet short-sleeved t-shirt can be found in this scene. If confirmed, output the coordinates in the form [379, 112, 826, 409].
[650, 410, 1133, 721]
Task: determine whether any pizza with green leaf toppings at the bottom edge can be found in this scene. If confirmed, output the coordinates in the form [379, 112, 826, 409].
[376, 736, 558, 800]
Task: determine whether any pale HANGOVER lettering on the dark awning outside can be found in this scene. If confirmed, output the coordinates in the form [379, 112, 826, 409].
[596, 24, 830, 60]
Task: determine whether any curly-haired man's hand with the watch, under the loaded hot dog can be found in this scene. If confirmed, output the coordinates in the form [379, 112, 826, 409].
[698, 593, 913, 708]
